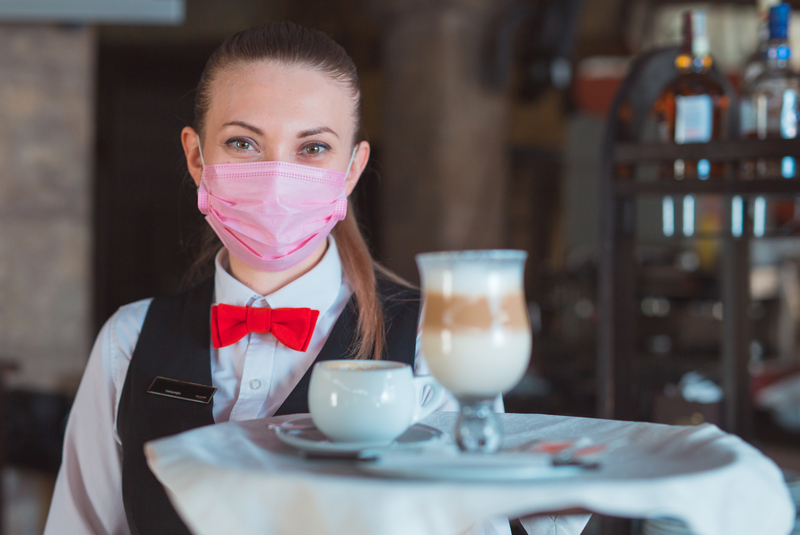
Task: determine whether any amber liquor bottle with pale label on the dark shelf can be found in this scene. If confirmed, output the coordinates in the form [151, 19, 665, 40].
[653, 10, 730, 180]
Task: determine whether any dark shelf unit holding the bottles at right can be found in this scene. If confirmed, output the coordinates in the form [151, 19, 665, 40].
[597, 48, 800, 438]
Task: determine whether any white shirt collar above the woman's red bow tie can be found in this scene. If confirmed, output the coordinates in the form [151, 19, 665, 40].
[214, 236, 342, 313]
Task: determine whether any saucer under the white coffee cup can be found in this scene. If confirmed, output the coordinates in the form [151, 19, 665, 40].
[270, 416, 444, 453]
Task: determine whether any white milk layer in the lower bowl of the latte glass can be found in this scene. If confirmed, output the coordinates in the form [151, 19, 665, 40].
[421, 329, 531, 396]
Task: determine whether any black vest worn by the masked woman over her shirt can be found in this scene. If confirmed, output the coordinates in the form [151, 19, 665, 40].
[117, 278, 419, 535]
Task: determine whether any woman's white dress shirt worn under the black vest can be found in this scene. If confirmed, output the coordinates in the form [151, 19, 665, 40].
[44, 238, 510, 535]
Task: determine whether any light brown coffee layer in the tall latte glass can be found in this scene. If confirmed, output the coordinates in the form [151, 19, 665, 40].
[422, 291, 529, 331]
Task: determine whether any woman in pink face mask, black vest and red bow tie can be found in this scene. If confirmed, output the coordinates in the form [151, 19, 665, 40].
[45, 23, 507, 534]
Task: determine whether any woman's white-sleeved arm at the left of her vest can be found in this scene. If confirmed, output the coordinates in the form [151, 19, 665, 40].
[44, 301, 150, 535]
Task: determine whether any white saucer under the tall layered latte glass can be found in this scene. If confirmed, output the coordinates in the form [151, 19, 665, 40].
[357, 450, 584, 482]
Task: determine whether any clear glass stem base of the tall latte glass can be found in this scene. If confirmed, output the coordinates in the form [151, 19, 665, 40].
[456, 396, 503, 453]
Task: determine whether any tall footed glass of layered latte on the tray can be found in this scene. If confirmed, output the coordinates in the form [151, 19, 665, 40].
[416, 250, 531, 452]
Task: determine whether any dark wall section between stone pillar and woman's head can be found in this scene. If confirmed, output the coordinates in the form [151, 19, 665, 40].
[94, 45, 214, 328]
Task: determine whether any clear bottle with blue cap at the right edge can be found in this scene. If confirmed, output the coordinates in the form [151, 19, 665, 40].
[742, 3, 800, 178]
